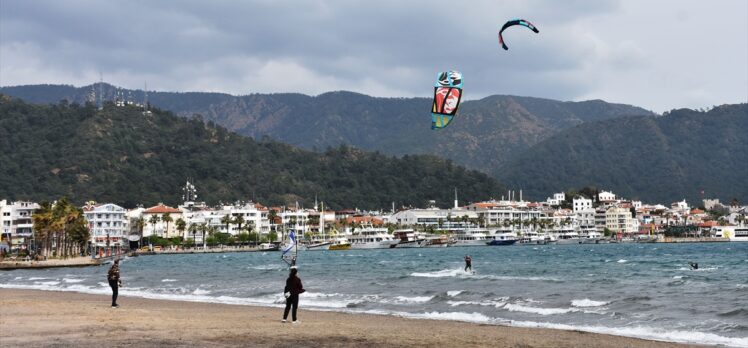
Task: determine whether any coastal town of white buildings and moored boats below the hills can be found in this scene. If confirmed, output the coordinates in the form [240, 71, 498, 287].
[0, 181, 748, 259]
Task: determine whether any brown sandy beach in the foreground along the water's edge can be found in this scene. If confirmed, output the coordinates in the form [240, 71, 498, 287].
[0, 289, 700, 348]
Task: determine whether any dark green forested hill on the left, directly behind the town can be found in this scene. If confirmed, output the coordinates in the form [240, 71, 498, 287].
[0, 95, 504, 209]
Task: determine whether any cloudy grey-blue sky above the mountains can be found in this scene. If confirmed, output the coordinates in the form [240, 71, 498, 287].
[0, 0, 748, 112]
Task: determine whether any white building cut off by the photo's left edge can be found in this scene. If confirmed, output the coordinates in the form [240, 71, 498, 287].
[0, 200, 39, 245]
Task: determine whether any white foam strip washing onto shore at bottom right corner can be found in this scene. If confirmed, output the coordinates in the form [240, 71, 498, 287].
[510, 321, 748, 347]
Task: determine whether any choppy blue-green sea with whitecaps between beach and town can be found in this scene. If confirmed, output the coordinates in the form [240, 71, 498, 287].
[0, 243, 748, 347]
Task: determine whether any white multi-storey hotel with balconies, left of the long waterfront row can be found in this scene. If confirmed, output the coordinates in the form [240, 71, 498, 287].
[83, 203, 130, 247]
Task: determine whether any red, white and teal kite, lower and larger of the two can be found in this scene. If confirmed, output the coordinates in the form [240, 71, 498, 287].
[431, 71, 462, 129]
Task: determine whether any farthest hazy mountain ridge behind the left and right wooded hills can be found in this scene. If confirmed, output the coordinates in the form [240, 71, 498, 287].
[0, 84, 653, 175]
